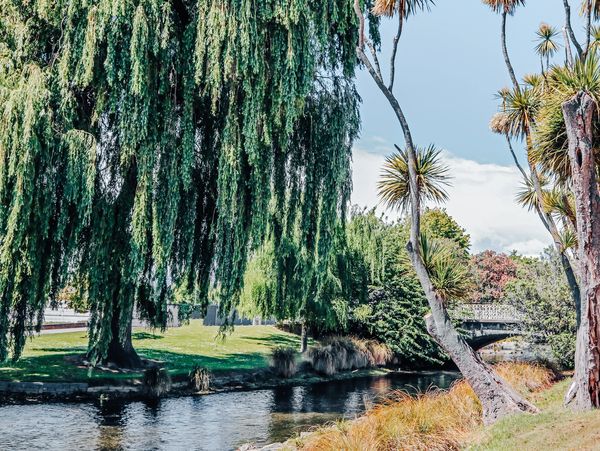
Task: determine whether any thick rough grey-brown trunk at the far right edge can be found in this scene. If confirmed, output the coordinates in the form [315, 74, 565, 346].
[563, 92, 600, 410]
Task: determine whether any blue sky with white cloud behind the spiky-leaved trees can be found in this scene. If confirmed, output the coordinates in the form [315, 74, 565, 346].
[352, 0, 583, 255]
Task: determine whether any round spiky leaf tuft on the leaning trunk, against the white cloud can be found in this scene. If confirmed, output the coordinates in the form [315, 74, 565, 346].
[377, 145, 450, 214]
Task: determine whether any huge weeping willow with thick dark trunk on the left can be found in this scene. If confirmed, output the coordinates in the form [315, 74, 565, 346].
[0, 0, 358, 367]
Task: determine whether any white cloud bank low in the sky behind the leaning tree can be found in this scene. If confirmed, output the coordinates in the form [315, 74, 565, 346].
[352, 148, 551, 255]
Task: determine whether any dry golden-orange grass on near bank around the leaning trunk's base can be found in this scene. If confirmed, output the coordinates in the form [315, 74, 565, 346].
[300, 363, 555, 451]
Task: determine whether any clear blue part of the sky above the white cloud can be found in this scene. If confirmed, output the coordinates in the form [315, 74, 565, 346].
[358, 0, 582, 164]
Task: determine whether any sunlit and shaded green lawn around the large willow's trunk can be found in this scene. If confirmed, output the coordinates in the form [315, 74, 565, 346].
[0, 320, 299, 381]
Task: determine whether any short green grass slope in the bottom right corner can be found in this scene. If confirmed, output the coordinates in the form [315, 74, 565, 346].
[467, 380, 600, 451]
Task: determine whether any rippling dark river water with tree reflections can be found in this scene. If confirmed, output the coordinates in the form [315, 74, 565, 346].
[0, 372, 458, 451]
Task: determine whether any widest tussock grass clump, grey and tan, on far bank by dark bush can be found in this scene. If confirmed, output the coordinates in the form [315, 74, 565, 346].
[307, 336, 393, 376]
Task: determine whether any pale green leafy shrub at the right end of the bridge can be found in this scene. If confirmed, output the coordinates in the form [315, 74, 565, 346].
[506, 248, 577, 368]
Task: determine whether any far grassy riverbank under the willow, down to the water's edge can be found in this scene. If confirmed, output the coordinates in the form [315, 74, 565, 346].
[0, 321, 422, 404]
